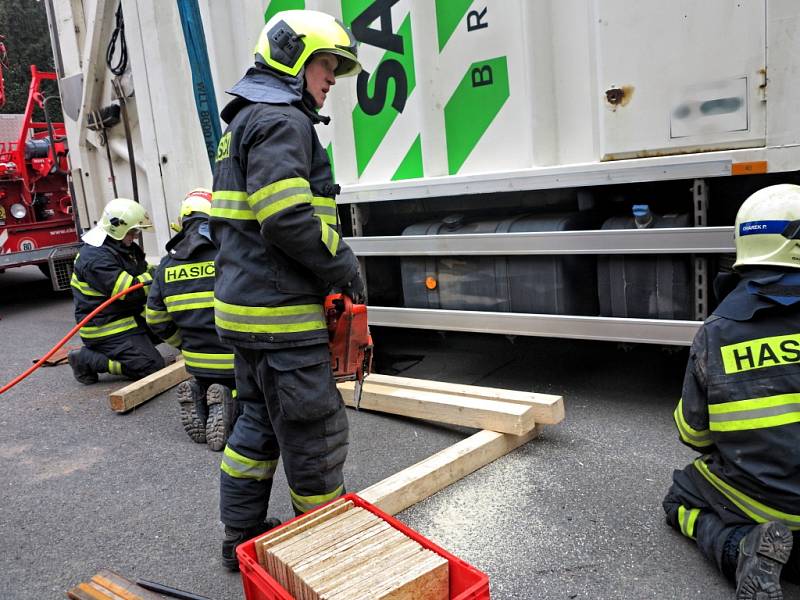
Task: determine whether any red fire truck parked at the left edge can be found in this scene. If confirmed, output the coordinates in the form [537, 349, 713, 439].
[0, 54, 79, 290]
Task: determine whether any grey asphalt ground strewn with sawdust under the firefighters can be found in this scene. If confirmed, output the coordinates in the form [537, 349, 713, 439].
[0, 268, 800, 600]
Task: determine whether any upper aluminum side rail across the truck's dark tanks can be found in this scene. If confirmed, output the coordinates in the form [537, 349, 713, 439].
[346, 227, 736, 257]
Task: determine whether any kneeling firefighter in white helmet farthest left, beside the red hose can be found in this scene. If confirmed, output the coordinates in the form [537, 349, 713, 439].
[68, 198, 164, 385]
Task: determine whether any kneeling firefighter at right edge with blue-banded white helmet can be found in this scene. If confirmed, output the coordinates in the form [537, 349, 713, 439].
[664, 184, 800, 600]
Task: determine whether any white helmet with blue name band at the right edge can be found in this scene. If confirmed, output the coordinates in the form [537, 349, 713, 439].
[733, 183, 800, 269]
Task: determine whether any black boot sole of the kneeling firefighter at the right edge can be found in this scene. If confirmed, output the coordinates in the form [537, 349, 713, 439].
[736, 521, 793, 600]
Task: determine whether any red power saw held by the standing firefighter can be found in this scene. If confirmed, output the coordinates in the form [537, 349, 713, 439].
[325, 294, 373, 410]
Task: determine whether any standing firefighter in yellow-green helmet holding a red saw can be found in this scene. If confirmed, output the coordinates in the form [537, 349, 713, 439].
[210, 10, 363, 570]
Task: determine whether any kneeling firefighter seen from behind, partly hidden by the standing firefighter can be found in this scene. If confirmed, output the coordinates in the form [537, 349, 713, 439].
[146, 188, 238, 452]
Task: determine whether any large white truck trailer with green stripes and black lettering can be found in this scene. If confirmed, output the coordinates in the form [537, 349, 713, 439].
[42, 0, 800, 346]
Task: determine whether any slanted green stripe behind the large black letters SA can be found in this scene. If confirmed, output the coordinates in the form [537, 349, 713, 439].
[353, 14, 417, 176]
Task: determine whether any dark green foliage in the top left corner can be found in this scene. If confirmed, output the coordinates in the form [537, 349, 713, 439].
[0, 0, 58, 119]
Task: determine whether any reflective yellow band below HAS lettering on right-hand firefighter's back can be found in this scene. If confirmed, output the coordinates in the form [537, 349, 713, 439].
[708, 393, 800, 431]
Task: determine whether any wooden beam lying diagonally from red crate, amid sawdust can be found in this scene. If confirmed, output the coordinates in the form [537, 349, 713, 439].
[358, 425, 541, 515]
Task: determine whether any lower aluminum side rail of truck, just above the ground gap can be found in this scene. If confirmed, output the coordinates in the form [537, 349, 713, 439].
[369, 306, 702, 346]
